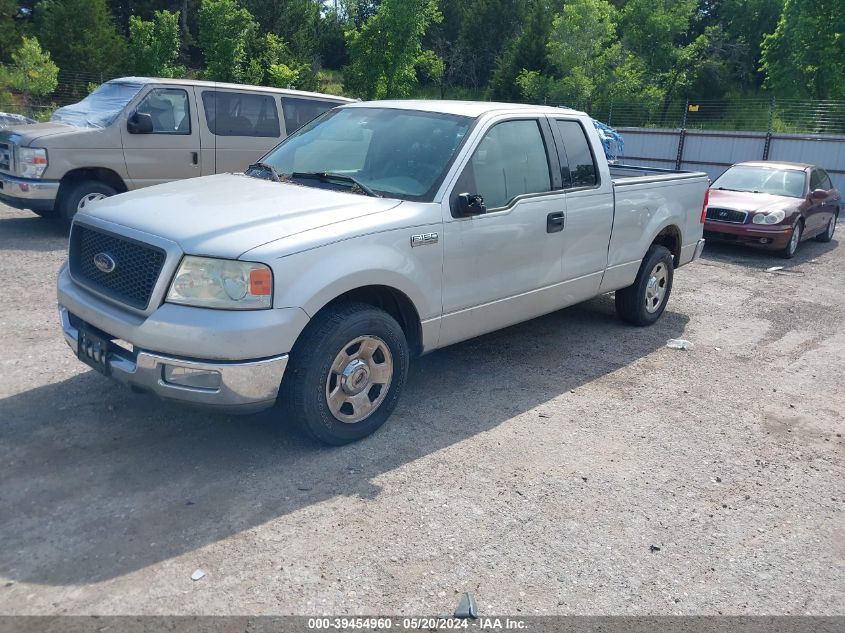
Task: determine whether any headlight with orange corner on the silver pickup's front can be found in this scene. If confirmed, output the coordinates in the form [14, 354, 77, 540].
[167, 255, 273, 310]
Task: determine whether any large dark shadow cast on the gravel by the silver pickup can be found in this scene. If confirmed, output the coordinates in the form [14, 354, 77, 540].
[0, 296, 688, 585]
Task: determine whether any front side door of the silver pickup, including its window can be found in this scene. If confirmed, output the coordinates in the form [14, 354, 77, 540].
[439, 117, 566, 346]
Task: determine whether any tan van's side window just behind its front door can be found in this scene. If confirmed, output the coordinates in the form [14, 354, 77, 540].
[202, 90, 281, 137]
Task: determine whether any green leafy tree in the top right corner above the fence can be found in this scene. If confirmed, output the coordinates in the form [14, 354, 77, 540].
[761, 0, 845, 99]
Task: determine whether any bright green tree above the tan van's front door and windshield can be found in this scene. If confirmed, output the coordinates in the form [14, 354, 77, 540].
[129, 11, 185, 77]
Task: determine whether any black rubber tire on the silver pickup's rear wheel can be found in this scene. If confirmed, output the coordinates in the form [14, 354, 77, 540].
[616, 244, 675, 326]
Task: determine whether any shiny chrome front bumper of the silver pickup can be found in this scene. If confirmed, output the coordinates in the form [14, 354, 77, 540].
[59, 305, 288, 413]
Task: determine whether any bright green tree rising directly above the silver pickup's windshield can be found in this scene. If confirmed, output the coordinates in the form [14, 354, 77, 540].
[344, 0, 442, 99]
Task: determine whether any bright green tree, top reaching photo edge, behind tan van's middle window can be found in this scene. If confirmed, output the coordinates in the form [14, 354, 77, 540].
[199, 0, 257, 82]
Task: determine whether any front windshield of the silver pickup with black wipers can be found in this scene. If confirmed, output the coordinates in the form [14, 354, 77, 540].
[262, 107, 473, 202]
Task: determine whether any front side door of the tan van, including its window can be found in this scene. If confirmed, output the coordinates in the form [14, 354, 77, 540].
[121, 86, 202, 189]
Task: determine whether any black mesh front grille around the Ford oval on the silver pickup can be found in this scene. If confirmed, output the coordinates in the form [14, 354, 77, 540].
[68, 224, 165, 310]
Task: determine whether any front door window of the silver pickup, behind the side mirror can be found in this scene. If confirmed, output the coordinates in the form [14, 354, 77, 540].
[456, 120, 551, 209]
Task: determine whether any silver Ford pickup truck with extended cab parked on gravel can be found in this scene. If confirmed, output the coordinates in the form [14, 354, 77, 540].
[58, 101, 708, 444]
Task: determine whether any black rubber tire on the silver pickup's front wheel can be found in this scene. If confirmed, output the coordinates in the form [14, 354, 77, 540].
[279, 302, 409, 446]
